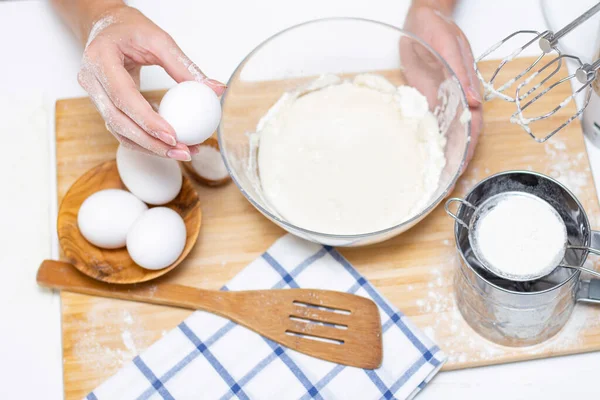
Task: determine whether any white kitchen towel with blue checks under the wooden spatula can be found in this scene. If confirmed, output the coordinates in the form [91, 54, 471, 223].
[87, 235, 446, 400]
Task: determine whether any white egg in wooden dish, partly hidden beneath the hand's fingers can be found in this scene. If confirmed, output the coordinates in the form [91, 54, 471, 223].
[117, 146, 183, 205]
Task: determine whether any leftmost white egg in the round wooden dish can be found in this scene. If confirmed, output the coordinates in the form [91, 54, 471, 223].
[77, 189, 148, 249]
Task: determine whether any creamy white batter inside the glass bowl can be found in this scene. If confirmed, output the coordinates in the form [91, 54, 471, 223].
[257, 74, 446, 235]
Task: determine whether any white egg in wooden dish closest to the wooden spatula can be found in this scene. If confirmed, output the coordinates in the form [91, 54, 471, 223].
[127, 207, 186, 269]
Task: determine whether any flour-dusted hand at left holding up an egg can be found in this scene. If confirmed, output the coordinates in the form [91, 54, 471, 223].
[54, 0, 225, 161]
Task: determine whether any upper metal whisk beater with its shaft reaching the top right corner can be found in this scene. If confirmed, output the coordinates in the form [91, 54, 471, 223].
[474, 2, 600, 102]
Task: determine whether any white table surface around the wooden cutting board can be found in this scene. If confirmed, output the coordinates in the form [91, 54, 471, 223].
[0, 0, 600, 400]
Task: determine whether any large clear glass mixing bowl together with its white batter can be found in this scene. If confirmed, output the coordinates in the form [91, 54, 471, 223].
[218, 18, 470, 246]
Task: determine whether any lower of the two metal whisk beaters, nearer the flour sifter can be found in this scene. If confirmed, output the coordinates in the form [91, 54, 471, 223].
[510, 54, 600, 143]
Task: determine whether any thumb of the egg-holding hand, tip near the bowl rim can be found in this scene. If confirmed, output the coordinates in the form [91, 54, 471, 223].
[152, 35, 227, 96]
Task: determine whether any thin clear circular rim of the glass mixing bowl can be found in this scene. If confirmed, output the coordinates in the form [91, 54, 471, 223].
[217, 17, 471, 240]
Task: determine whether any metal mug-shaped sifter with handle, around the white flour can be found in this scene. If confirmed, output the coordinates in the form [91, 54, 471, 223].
[448, 171, 600, 346]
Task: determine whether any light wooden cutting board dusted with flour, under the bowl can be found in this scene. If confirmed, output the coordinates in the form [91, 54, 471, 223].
[56, 59, 600, 399]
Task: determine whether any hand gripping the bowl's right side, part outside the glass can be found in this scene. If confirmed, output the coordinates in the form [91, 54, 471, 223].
[404, 0, 483, 161]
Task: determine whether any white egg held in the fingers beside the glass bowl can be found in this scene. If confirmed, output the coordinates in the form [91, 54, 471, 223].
[158, 81, 221, 145]
